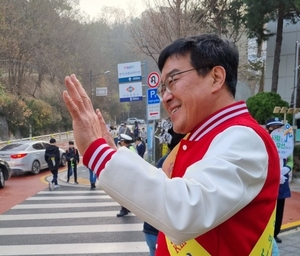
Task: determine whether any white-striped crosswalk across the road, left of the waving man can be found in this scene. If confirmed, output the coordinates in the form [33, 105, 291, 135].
[0, 187, 149, 256]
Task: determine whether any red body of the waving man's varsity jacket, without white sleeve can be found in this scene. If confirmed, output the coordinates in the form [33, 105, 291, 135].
[156, 102, 279, 256]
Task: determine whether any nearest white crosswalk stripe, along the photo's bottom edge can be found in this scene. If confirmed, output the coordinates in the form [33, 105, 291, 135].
[0, 242, 149, 256]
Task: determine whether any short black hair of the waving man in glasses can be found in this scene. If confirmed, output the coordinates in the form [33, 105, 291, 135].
[158, 34, 239, 97]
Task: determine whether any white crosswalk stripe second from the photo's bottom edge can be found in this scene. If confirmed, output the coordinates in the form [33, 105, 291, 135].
[0, 223, 143, 236]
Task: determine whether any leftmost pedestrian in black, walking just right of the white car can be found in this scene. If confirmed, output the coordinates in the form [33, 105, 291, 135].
[45, 138, 60, 191]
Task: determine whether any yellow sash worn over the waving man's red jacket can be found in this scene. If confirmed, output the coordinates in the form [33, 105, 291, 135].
[162, 134, 275, 256]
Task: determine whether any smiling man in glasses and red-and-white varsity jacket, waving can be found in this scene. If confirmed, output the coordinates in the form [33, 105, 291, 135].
[63, 34, 280, 256]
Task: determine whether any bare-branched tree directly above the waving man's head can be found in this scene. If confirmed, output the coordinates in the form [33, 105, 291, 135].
[130, 0, 245, 61]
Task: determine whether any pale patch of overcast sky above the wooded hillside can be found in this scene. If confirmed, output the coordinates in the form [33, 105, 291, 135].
[80, 0, 145, 18]
